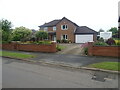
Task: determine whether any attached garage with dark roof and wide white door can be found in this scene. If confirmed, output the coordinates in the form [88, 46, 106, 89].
[75, 26, 97, 43]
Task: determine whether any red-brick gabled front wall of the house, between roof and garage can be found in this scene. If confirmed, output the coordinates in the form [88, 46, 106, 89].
[56, 19, 76, 42]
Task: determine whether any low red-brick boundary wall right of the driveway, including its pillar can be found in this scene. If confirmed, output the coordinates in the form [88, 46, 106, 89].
[88, 42, 120, 57]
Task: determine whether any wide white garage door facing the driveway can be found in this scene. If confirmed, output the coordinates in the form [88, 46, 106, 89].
[75, 34, 93, 43]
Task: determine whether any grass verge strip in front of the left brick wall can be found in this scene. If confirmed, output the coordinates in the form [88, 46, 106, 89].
[0, 51, 35, 59]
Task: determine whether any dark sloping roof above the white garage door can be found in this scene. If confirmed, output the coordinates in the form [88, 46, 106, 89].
[75, 26, 97, 34]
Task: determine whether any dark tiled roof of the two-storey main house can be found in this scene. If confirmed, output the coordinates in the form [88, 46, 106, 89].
[39, 17, 78, 27]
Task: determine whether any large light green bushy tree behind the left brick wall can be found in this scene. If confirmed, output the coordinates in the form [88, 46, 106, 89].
[12, 26, 32, 41]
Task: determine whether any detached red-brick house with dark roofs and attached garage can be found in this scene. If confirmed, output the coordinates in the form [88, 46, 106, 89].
[39, 17, 97, 43]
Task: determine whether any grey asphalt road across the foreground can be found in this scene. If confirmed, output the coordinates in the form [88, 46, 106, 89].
[2, 58, 118, 88]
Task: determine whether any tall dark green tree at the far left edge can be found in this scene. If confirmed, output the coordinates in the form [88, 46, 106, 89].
[0, 19, 12, 41]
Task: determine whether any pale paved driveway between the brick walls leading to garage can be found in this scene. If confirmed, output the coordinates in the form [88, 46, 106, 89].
[57, 43, 83, 55]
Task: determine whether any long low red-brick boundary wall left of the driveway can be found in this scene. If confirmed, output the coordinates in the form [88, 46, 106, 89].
[0, 43, 57, 53]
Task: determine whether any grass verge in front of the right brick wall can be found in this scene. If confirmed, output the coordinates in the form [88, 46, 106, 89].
[88, 62, 120, 71]
